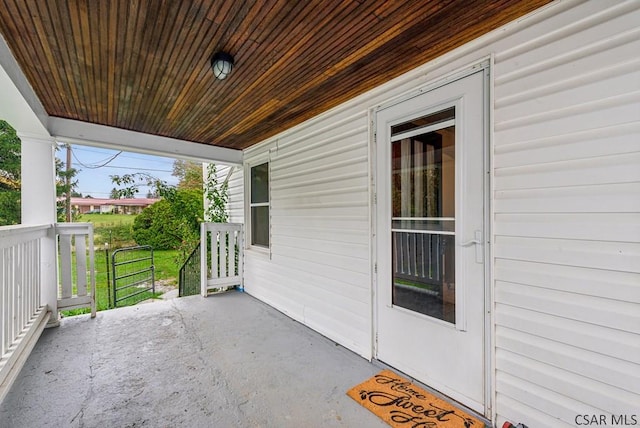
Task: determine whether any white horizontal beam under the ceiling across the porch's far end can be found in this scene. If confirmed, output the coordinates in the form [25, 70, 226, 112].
[48, 117, 243, 165]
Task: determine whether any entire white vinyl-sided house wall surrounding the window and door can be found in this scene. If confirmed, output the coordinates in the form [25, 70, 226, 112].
[232, 0, 640, 427]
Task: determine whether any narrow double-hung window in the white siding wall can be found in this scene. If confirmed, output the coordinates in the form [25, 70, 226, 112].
[250, 162, 269, 247]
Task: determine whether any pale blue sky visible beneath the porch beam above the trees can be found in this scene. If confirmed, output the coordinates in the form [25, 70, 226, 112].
[56, 144, 178, 198]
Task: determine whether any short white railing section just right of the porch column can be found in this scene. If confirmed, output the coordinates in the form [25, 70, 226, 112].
[56, 223, 96, 318]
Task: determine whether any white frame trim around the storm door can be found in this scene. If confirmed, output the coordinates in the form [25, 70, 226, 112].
[368, 55, 495, 420]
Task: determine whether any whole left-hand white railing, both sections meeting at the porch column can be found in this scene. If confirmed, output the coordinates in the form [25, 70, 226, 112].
[0, 223, 96, 401]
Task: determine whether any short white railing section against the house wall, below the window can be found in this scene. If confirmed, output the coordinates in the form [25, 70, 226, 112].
[200, 223, 244, 296]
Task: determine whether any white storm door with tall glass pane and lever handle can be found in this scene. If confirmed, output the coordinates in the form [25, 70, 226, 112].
[376, 70, 486, 413]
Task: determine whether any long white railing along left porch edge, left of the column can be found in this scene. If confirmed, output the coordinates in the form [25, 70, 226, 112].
[0, 225, 53, 401]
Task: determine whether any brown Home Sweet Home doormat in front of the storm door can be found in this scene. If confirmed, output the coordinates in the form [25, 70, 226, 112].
[347, 370, 485, 428]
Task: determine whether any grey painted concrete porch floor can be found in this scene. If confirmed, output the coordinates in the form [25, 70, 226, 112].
[0, 292, 387, 428]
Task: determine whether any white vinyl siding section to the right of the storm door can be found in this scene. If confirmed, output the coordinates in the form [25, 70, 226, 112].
[493, 1, 640, 427]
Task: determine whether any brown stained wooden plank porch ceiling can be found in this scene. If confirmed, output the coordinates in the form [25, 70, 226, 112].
[0, 0, 548, 149]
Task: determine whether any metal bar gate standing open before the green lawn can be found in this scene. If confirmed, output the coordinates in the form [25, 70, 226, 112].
[111, 245, 155, 307]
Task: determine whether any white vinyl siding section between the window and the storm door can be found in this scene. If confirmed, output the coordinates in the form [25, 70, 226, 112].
[245, 110, 371, 357]
